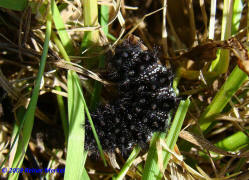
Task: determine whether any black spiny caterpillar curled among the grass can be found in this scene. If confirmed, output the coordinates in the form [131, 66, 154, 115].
[85, 36, 179, 153]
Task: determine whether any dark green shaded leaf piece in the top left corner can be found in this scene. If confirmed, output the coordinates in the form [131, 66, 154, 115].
[0, 0, 28, 11]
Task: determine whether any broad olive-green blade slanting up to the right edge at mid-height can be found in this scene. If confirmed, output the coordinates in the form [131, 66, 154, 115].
[199, 66, 248, 131]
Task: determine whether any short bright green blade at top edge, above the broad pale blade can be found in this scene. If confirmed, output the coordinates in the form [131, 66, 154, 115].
[52, 0, 74, 55]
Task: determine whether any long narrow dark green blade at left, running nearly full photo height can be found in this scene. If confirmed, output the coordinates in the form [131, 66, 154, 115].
[9, 3, 54, 179]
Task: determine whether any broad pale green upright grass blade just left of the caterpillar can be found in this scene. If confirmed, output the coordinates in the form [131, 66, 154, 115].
[64, 70, 85, 179]
